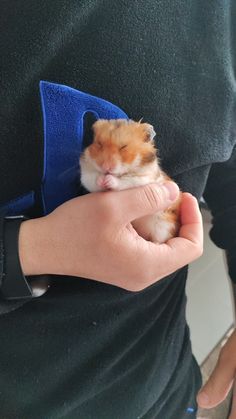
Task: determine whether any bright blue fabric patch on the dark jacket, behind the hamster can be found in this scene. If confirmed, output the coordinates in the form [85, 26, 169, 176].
[0, 81, 128, 215]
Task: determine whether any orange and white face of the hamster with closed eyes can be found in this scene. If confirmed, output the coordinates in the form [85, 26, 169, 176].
[87, 119, 156, 176]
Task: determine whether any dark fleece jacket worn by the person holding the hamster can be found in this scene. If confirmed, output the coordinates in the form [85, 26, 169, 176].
[0, 0, 236, 419]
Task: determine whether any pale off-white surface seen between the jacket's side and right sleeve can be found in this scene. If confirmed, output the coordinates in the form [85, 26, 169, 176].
[186, 210, 234, 364]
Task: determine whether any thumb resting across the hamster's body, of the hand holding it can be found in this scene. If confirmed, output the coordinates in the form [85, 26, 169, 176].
[116, 182, 179, 223]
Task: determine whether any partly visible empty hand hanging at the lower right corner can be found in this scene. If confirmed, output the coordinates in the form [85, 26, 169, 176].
[197, 331, 236, 419]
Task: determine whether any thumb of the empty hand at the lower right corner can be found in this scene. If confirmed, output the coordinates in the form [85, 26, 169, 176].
[197, 359, 234, 409]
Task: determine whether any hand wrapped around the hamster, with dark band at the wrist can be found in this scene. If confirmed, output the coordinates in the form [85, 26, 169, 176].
[19, 182, 203, 291]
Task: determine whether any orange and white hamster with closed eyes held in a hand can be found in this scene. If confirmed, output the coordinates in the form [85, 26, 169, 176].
[80, 119, 181, 243]
